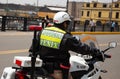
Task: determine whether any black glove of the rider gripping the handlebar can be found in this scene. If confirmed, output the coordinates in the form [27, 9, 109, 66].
[91, 48, 104, 61]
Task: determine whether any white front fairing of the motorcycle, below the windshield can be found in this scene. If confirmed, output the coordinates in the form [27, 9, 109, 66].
[70, 56, 101, 79]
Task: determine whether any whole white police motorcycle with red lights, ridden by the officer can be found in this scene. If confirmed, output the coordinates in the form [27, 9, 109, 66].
[1, 26, 117, 79]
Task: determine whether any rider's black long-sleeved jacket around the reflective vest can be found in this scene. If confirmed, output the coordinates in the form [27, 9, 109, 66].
[30, 27, 90, 62]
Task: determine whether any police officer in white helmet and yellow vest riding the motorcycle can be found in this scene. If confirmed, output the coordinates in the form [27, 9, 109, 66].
[30, 12, 100, 79]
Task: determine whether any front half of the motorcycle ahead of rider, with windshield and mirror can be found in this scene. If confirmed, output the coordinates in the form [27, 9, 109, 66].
[70, 35, 117, 79]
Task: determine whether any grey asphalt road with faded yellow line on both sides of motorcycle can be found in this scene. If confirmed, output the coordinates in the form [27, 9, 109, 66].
[0, 32, 120, 79]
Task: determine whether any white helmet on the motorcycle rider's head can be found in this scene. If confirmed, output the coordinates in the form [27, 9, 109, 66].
[53, 12, 71, 24]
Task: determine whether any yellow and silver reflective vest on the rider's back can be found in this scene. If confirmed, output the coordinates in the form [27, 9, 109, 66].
[40, 27, 66, 49]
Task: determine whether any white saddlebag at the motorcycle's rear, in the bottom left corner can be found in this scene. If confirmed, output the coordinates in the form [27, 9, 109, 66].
[1, 67, 16, 79]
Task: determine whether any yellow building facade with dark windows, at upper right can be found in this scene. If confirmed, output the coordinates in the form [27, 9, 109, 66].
[80, 1, 120, 24]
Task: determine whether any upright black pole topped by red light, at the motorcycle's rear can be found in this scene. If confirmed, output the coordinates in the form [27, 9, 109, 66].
[29, 25, 42, 79]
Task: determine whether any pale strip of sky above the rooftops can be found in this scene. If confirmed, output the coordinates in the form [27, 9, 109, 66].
[0, 0, 116, 6]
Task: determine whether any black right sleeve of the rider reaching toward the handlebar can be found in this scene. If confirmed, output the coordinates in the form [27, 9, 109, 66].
[62, 34, 91, 54]
